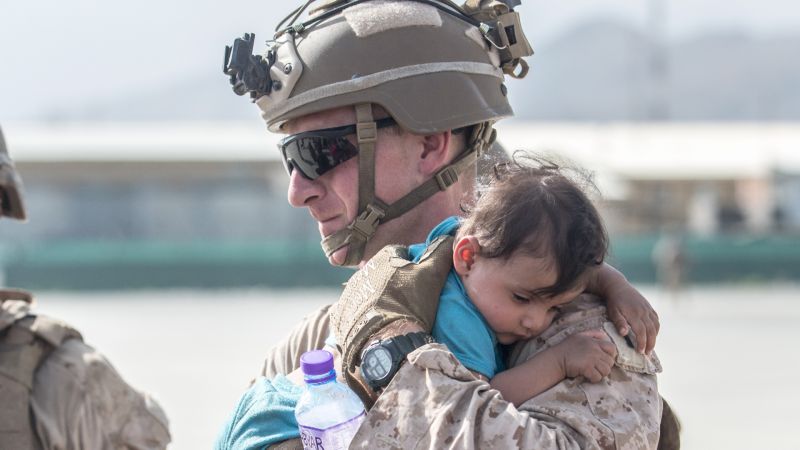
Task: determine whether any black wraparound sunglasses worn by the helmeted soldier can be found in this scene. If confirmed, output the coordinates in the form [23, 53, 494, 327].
[278, 117, 397, 180]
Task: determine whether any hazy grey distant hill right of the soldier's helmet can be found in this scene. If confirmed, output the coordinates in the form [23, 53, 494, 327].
[509, 22, 800, 121]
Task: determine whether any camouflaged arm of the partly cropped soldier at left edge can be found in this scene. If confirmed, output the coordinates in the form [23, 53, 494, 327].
[31, 339, 170, 450]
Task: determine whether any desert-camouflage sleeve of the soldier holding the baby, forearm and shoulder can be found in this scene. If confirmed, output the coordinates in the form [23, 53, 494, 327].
[353, 296, 661, 449]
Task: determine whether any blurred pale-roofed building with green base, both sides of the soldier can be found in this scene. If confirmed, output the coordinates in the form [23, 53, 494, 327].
[0, 121, 800, 288]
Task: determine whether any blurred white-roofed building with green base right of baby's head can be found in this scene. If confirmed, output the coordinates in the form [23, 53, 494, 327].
[500, 122, 800, 282]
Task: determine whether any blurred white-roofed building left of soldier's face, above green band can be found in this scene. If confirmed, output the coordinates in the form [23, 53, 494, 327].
[4, 123, 304, 240]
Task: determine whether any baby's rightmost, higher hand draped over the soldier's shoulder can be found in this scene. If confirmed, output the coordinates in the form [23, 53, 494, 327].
[606, 281, 661, 355]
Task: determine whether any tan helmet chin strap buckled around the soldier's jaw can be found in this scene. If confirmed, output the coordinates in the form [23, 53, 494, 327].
[321, 103, 496, 267]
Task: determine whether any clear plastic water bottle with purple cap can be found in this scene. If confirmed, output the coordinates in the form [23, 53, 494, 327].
[294, 350, 366, 450]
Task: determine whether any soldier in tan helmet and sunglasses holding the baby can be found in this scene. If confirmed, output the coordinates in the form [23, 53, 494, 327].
[218, 0, 676, 449]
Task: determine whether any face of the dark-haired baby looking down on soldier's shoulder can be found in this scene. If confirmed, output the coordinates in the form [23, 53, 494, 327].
[453, 238, 584, 344]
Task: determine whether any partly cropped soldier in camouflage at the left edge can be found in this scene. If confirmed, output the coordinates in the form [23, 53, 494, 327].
[0, 125, 170, 450]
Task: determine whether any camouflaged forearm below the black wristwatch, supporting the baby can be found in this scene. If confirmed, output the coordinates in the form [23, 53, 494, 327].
[351, 344, 597, 450]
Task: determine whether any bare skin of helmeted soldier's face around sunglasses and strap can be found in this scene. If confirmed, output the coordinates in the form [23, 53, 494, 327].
[285, 107, 423, 265]
